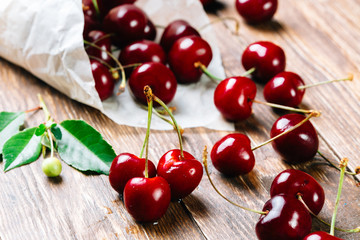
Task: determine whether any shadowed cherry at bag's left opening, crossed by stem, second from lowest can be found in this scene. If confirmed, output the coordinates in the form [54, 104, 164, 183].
[86, 30, 114, 66]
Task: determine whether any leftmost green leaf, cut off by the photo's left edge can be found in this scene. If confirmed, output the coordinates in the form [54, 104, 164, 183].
[0, 112, 25, 154]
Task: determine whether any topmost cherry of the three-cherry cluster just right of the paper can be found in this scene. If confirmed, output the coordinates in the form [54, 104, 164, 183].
[241, 41, 286, 83]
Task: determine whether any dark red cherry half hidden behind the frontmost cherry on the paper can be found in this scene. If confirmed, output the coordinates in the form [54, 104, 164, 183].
[119, 40, 166, 67]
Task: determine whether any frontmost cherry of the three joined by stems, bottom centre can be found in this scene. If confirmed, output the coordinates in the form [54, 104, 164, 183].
[123, 177, 171, 222]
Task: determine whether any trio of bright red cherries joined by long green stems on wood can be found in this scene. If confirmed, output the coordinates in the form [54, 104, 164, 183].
[109, 86, 203, 222]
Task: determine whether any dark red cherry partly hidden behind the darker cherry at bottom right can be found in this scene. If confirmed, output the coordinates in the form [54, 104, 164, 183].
[270, 169, 325, 215]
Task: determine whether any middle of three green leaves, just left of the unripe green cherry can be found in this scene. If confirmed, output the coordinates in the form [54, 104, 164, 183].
[3, 127, 41, 172]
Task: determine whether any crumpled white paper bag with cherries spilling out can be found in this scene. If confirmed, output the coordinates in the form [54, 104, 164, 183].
[0, 0, 234, 130]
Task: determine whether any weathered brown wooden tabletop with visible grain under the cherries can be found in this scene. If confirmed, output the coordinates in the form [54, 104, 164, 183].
[0, 0, 360, 240]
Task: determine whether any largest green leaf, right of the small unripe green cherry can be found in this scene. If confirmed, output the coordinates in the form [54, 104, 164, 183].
[53, 120, 116, 175]
